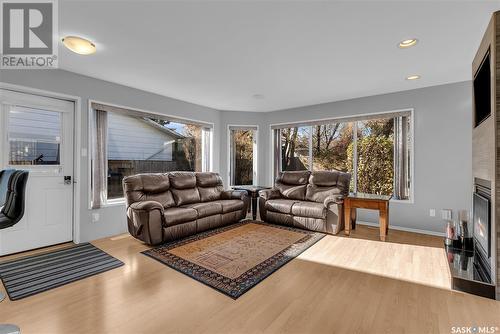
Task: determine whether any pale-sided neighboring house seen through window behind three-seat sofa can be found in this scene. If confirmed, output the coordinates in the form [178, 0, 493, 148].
[108, 112, 185, 161]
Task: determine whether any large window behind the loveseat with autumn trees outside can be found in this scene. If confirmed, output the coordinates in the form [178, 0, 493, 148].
[273, 111, 412, 200]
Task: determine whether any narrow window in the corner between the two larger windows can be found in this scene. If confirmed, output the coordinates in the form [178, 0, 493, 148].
[229, 126, 257, 185]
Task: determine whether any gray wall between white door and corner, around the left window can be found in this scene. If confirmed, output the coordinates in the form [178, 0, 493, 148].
[0, 70, 224, 241]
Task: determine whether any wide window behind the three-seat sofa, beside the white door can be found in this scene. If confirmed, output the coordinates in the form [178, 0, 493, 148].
[92, 105, 211, 208]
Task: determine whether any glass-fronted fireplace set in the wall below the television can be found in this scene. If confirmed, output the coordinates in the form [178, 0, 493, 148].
[472, 178, 491, 282]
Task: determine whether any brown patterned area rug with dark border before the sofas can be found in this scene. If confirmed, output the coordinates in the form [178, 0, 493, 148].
[142, 220, 324, 299]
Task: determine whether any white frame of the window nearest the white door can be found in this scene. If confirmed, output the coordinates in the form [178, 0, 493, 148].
[88, 99, 215, 210]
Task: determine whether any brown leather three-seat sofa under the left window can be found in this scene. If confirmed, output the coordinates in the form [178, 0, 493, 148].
[123, 172, 250, 245]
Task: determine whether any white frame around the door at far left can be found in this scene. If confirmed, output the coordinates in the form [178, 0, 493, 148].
[0, 82, 82, 244]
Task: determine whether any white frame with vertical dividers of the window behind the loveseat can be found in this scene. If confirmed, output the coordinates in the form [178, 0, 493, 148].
[269, 108, 415, 204]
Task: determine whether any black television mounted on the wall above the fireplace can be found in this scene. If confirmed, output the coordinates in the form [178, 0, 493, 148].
[474, 50, 491, 127]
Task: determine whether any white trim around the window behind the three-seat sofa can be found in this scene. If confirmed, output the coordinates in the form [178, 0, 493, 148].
[87, 99, 215, 210]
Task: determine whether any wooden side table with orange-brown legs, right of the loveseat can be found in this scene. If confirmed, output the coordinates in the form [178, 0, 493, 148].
[344, 193, 392, 241]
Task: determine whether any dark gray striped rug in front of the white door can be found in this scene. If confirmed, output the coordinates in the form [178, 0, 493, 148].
[0, 243, 123, 300]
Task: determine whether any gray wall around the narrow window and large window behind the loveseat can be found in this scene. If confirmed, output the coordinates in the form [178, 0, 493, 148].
[221, 82, 472, 232]
